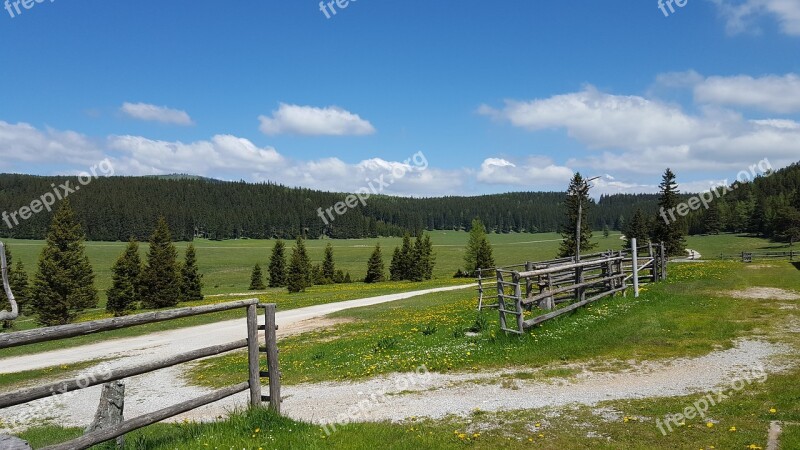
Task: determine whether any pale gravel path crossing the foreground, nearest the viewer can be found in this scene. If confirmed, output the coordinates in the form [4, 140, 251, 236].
[0, 340, 791, 429]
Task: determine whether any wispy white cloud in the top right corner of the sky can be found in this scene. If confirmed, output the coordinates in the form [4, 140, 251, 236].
[711, 0, 800, 36]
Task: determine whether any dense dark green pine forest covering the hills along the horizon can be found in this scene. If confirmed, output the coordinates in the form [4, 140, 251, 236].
[0, 165, 800, 241]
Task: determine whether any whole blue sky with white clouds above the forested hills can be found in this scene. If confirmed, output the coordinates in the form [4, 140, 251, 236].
[0, 0, 800, 196]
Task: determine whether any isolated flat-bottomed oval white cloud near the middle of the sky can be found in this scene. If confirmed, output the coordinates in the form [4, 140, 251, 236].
[259, 103, 375, 136]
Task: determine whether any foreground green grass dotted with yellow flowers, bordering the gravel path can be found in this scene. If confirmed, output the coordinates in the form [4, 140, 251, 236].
[18, 262, 800, 450]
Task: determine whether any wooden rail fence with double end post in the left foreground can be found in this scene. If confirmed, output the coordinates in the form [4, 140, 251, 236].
[0, 299, 281, 450]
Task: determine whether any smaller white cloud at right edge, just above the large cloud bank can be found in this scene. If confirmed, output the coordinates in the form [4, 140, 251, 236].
[694, 73, 800, 113]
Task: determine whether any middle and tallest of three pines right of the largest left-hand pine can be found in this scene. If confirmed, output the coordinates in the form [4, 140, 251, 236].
[141, 217, 181, 308]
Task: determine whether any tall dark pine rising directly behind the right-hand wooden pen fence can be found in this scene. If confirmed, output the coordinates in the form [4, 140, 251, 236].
[558, 172, 596, 258]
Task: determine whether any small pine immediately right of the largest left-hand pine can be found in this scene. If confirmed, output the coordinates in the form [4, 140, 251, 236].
[106, 239, 142, 317]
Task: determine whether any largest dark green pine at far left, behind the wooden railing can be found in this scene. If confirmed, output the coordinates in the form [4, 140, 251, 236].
[31, 199, 98, 326]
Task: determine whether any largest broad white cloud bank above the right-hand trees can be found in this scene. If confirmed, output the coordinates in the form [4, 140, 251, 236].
[479, 83, 800, 175]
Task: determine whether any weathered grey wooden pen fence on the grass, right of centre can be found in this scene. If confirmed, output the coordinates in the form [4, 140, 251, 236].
[478, 241, 667, 334]
